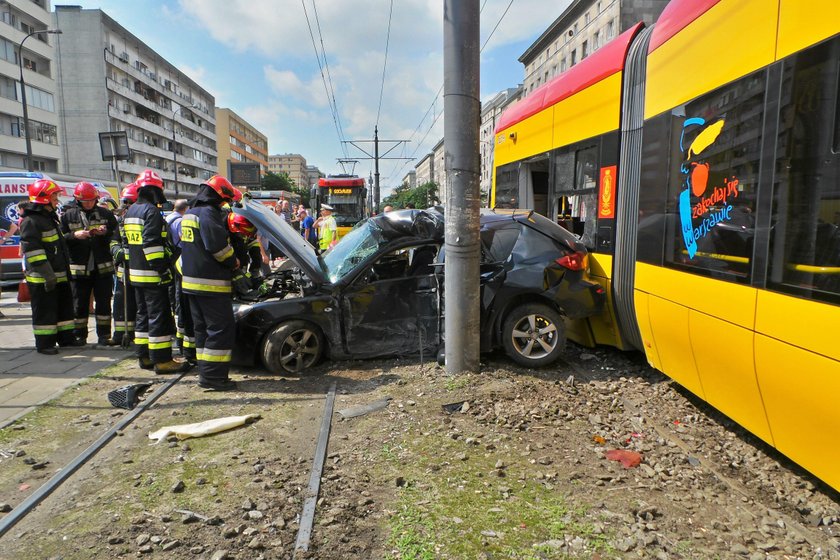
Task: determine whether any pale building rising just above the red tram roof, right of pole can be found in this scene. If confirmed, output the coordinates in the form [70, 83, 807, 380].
[519, 0, 668, 97]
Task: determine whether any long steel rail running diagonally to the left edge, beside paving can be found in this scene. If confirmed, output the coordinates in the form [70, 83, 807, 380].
[0, 373, 185, 537]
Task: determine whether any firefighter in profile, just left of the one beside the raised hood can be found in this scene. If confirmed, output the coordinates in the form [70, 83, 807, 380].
[124, 169, 190, 374]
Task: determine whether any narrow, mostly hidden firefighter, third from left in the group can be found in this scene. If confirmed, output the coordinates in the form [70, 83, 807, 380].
[111, 183, 137, 348]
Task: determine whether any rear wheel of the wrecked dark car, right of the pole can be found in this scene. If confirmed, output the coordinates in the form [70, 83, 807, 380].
[502, 303, 566, 367]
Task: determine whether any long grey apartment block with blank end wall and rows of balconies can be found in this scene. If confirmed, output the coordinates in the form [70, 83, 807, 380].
[53, 6, 218, 193]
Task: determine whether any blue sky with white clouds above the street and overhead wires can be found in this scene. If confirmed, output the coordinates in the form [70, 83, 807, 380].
[60, 0, 571, 196]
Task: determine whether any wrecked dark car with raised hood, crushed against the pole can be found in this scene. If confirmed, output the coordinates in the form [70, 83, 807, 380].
[233, 201, 604, 374]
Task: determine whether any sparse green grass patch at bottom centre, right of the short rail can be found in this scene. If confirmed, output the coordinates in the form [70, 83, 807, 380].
[370, 427, 615, 560]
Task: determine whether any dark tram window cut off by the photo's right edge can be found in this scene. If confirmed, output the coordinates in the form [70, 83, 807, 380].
[768, 39, 840, 303]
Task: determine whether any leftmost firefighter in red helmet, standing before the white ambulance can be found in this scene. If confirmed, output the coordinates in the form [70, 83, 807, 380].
[20, 179, 85, 355]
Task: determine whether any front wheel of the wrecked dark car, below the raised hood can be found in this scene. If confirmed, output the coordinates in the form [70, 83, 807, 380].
[262, 321, 324, 375]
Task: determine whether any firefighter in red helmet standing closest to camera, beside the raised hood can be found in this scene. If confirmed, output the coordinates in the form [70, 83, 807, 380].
[181, 175, 239, 391]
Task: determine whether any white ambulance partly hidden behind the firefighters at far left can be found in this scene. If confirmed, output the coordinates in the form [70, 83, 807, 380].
[0, 171, 119, 285]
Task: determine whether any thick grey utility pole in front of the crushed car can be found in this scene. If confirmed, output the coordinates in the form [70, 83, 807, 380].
[443, 0, 481, 374]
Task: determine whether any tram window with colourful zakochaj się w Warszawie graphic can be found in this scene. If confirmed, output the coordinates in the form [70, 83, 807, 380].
[664, 70, 766, 284]
